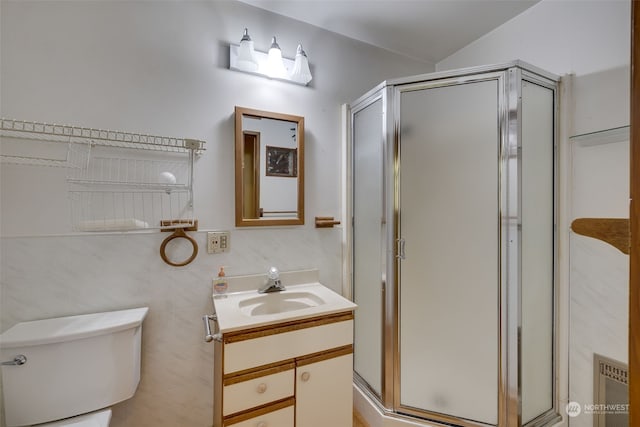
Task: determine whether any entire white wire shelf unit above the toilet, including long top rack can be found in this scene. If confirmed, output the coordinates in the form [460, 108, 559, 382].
[0, 118, 205, 232]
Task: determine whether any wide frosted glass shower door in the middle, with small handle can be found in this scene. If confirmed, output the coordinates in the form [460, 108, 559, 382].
[398, 79, 501, 425]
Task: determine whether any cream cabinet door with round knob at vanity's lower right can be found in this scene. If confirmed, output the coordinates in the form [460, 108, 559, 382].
[296, 354, 353, 427]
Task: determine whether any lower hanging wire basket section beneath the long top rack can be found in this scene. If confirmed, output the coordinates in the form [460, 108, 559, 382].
[67, 144, 195, 231]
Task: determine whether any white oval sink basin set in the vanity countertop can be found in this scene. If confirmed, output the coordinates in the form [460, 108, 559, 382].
[238, 291, 326, 316]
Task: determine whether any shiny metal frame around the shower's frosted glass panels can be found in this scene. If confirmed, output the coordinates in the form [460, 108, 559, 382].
[347, 61, 560, 427]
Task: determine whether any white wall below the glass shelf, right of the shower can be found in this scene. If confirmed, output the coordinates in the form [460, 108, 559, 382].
[569, 130, 629, 427]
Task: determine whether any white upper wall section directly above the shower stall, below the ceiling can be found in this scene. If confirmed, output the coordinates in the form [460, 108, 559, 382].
[436, 0, 630, 74]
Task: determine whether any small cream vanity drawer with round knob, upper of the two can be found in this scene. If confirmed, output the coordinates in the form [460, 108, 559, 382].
[222, 363, 295, 416]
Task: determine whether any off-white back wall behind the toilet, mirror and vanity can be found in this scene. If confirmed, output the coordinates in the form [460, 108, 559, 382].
[0, 1, 433, 427]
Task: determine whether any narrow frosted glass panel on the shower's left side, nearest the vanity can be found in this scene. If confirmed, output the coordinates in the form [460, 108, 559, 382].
[352, 98, 386, 396]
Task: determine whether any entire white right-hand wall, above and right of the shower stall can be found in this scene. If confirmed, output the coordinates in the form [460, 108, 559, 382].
[436, 0, 630, 426]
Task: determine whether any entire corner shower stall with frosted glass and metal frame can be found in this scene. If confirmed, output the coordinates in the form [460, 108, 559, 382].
[349, 61, 559, 427]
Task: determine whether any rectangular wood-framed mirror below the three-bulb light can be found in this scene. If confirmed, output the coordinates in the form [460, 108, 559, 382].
[235, 107, 304, 227]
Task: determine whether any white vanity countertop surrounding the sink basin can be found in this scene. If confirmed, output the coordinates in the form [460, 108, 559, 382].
[213, 282, 357, 334]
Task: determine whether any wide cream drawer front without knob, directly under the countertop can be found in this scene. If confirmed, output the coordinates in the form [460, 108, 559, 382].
[224, 320, 353, 375]
